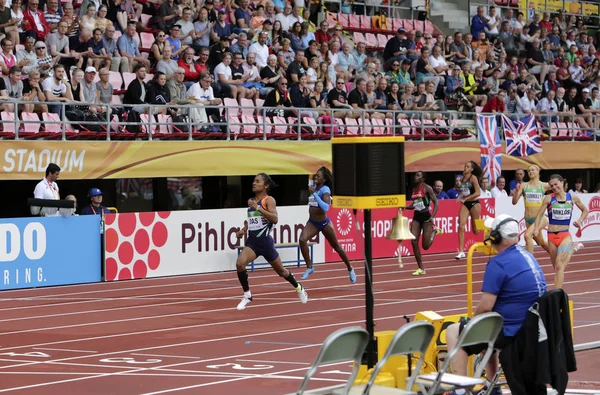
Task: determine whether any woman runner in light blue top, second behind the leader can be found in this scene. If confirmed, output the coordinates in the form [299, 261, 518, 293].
[300, 167, 356, 284]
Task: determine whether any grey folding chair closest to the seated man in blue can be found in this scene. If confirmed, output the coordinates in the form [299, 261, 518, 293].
[417, 312, 504, 395]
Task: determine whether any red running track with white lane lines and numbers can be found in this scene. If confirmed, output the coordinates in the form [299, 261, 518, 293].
[0, 243, 600, 395]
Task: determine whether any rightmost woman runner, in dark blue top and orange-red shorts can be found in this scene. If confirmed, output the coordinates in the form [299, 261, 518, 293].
[533, 174, 588, 289]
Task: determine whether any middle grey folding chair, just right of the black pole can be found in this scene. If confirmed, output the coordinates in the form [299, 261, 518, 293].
[350, 321, 435, 395]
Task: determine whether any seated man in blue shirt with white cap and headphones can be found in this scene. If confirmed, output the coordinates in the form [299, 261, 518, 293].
[446, 214, 546, 395]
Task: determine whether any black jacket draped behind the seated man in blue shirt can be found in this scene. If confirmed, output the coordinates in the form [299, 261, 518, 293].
[500, 289, 577, 395]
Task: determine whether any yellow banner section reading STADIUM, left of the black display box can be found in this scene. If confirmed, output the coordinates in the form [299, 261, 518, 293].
[0, 141, 331, 180]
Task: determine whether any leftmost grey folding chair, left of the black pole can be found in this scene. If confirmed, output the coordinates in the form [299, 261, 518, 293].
[295, 326, 369, 395]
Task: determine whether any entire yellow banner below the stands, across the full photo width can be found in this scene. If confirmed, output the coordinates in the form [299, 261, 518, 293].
[0, 141, 600, 180]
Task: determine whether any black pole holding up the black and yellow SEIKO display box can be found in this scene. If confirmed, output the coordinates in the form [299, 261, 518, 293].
[364, 209, 377, 369]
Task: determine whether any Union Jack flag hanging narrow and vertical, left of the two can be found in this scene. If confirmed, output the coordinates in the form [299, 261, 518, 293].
[477, 114, 502, 185]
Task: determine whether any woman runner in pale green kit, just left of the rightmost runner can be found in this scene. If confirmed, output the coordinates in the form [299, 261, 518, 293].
[512, 165, 550, 254]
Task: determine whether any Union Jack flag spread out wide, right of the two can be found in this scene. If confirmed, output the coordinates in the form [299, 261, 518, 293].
[502, 114, 542, 156]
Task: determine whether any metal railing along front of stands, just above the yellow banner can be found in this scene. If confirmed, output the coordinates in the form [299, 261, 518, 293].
[0, 102, 600, 141]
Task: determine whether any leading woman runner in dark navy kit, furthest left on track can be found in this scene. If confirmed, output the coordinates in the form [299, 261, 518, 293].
[235, 173, 308, 310]
